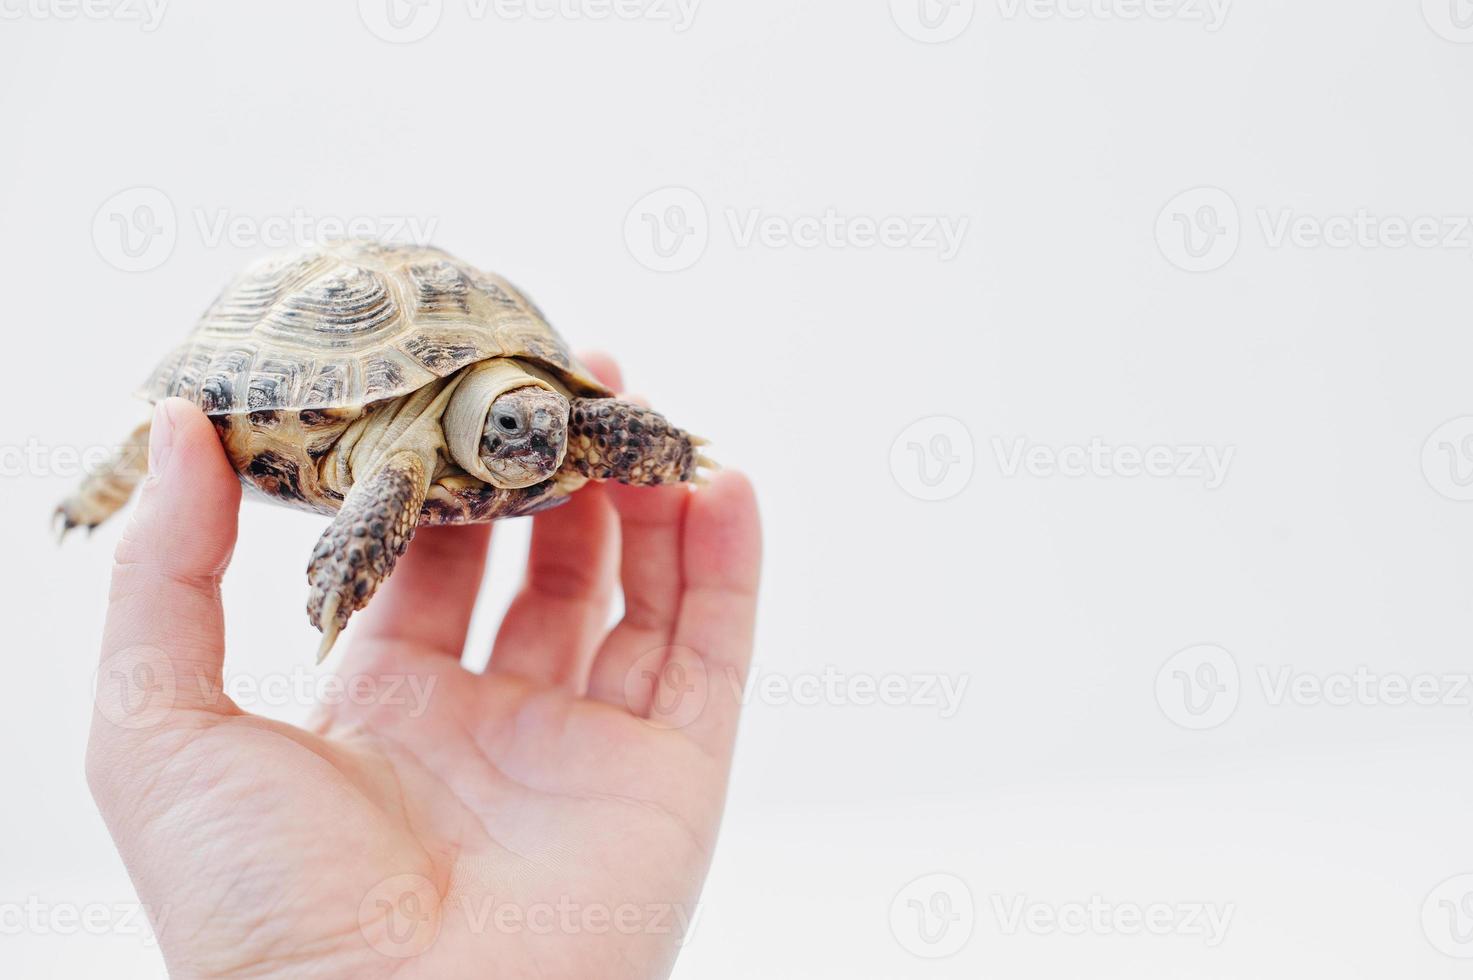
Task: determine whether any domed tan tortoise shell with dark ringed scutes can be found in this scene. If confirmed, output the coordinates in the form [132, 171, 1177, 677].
[140, 242, 610, 416]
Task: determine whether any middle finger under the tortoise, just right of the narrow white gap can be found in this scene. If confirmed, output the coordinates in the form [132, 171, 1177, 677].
[488, 485, 619, 693]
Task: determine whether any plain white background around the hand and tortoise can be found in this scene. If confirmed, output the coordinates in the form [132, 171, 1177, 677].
[0, 0, 1473, 980]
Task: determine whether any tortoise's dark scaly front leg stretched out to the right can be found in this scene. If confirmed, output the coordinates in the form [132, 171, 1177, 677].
[564, 398, 716, 486]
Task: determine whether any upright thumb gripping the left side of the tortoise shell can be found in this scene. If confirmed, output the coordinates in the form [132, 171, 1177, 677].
[93, 398, 240, 743]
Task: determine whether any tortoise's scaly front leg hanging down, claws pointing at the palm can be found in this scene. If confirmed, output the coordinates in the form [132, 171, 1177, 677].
[306, 452, 429, 663]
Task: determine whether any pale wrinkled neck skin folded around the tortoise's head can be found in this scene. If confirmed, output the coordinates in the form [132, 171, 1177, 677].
[318, 358, 567, 497]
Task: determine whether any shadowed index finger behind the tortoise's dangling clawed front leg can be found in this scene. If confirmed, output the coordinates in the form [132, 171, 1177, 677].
[348, 525, 491, 662]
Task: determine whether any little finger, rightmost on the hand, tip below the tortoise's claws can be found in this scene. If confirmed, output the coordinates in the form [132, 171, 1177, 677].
[665, 473, 762, 757]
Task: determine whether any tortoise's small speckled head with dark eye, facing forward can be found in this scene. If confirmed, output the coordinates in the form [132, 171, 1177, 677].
[480, 386, 567, 489]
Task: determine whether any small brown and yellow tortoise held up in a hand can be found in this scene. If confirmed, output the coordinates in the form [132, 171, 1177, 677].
[55, 240, 714, 662]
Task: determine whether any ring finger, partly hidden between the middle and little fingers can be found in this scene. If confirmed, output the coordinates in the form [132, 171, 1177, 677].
[588, 486, 691, 716]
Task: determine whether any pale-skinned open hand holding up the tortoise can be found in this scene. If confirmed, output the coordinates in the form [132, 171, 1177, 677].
[87, 357, 760, 977]
